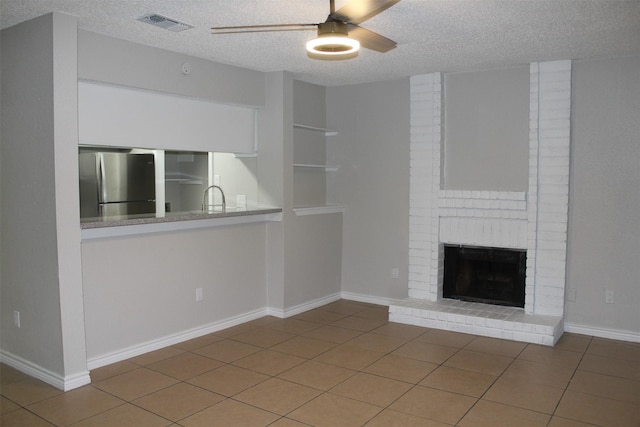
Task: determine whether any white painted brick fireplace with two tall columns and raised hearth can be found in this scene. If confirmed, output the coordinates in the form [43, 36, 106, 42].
[389, 61, 571, 345]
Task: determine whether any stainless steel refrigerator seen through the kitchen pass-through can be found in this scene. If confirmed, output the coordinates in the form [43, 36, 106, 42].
[79, 152, 156, 218]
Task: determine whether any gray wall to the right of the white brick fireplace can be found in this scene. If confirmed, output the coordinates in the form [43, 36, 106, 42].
[566, 56, 640, 334]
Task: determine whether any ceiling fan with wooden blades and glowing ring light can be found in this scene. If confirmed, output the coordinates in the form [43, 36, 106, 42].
[211, 0, 400, 59]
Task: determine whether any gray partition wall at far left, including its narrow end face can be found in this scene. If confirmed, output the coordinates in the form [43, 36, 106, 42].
[0, 14, 89, 390]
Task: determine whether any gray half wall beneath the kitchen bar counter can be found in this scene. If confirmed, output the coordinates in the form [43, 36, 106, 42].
[82, 223, 267, 369]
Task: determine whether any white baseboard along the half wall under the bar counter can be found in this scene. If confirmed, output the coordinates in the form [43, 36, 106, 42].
[87, 308, 268, 370]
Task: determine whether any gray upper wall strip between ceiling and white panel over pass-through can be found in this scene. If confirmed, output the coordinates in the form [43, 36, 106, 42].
[78, 30, 265, 107]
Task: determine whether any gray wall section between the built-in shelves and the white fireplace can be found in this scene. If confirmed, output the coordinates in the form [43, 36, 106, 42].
[327, 79, 409, 298]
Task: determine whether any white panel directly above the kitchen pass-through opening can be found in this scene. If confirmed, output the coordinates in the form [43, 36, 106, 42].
[78, 82, 255, 153]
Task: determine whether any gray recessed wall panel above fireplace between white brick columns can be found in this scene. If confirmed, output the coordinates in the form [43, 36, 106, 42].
[444, 67, 529, 191]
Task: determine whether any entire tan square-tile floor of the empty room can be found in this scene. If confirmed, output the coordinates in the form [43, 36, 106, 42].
[0, 300, 640, 427]
